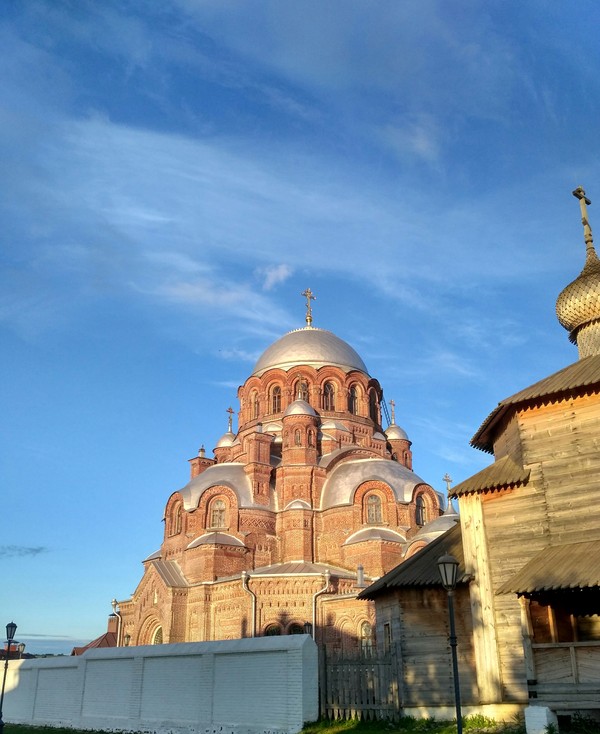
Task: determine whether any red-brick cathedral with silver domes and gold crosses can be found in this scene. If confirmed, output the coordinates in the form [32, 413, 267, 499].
[115, 289, 458, 653]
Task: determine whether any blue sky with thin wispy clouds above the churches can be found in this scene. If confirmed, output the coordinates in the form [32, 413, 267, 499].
[0, 0, 600, 652]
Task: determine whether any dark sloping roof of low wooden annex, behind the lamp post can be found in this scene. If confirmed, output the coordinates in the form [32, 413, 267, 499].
[358, 524, 470, 599]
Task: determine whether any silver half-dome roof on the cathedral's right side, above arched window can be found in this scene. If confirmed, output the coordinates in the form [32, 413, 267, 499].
[321, 458, 427, 510]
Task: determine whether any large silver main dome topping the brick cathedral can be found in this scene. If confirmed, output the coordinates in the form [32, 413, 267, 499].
[252, 326, 368, 375]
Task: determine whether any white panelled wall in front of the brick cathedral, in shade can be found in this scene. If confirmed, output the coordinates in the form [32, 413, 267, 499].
[3, 635, 318, 734]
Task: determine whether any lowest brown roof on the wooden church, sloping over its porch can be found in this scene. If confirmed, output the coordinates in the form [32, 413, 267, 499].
[497, 540, 600, 594]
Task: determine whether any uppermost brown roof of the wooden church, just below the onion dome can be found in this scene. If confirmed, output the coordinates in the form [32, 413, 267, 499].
[471, 354, 600, 454]
